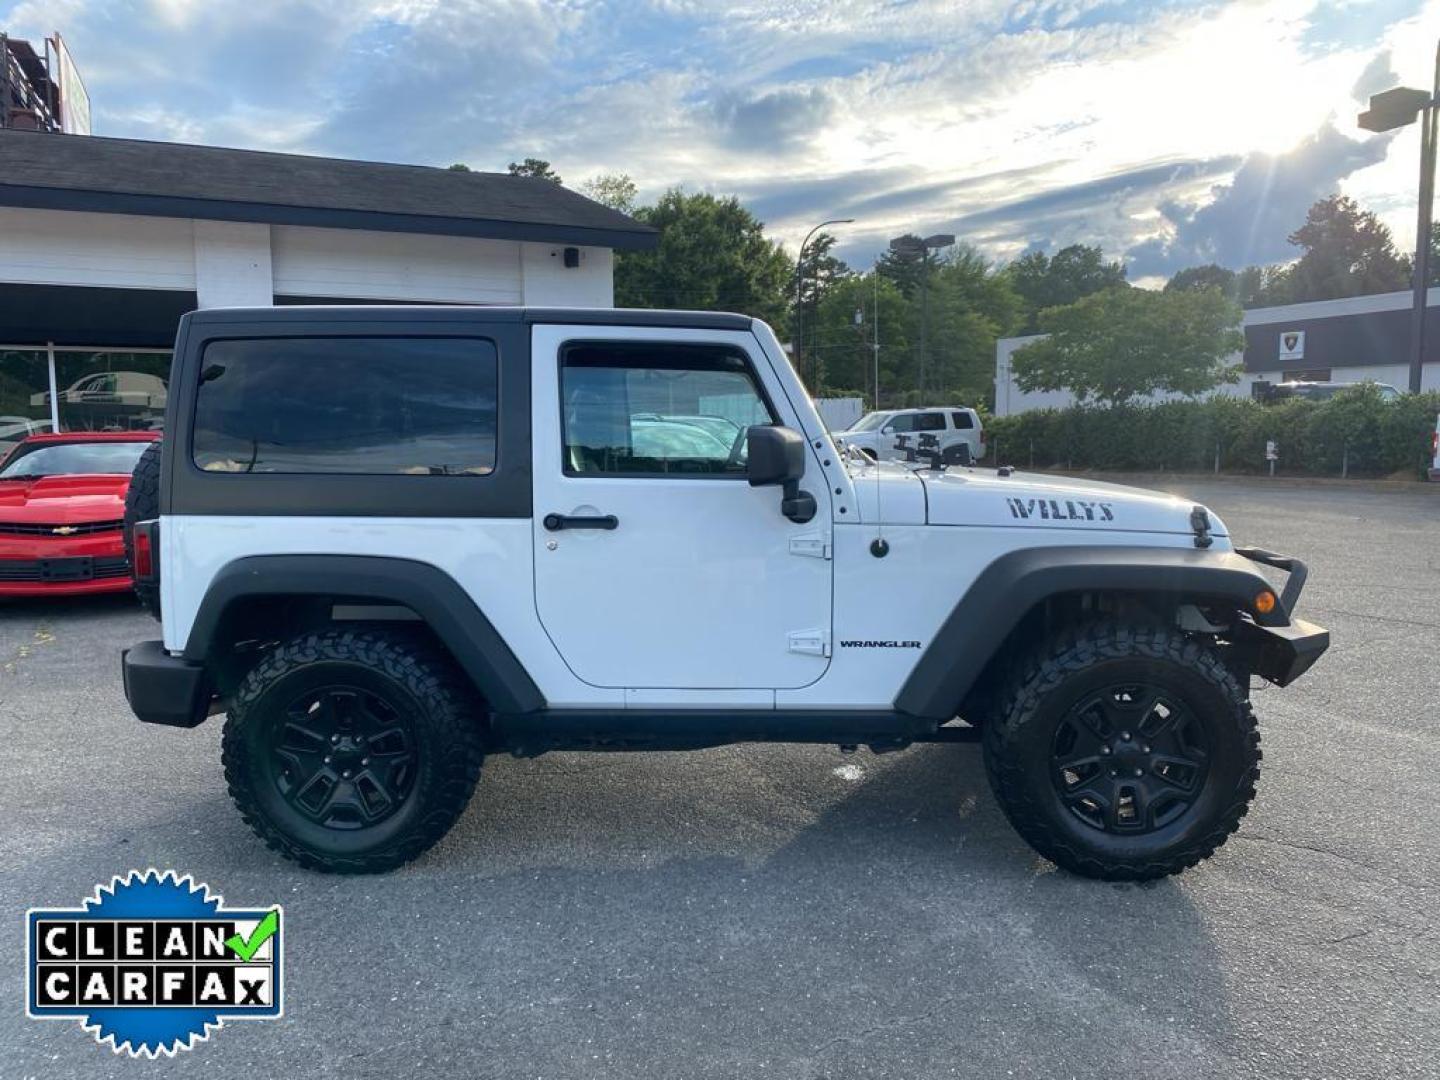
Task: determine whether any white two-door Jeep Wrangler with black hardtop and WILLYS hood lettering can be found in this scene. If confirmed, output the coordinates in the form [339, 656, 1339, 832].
[122, 307, 1329, 880]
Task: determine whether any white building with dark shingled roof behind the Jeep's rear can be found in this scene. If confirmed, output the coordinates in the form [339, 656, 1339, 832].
[0, 130, 655, 448]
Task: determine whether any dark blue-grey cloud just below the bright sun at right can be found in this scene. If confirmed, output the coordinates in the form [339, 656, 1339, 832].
[1128, 124, 1390, 276]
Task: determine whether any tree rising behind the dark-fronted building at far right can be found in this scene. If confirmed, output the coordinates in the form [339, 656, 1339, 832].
[1287, 194, 1410, 302]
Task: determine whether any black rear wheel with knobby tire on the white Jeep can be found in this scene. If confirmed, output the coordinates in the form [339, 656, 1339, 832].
[222, 629, 484, 874]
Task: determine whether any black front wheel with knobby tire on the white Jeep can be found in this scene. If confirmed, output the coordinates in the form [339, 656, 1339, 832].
[985, 622, 1260, 881]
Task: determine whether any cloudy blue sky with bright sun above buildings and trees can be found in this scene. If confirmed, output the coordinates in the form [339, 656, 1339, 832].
[11, 0, 1440, 284]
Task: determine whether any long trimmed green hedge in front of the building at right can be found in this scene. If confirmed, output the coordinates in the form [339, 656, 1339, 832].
[985, 387, 1440, 477]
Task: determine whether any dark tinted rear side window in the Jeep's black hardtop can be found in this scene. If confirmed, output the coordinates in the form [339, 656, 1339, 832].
[194, 337, 497, 477]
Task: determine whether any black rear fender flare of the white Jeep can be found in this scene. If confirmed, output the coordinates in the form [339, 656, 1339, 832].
[184, 554, 546, 713]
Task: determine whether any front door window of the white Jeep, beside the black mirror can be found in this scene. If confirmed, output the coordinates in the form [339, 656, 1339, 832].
[560, 341, 776, 477]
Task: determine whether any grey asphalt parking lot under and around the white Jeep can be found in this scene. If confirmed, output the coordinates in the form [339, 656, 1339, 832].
[0, 481, 1440, 1080]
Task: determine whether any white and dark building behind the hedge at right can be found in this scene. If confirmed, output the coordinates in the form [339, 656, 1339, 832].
[995, 288, 1440, 416]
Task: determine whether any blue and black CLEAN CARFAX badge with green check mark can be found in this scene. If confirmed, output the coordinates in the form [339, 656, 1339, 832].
[26, 870, 284, 1057]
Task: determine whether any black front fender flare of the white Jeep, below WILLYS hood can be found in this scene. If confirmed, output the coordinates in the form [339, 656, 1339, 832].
[894, 546, 1287, 723]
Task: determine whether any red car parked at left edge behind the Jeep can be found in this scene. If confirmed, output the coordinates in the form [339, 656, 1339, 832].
[0, 431, 160, 596]
